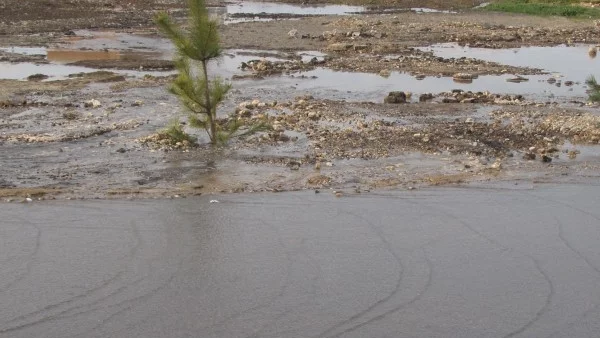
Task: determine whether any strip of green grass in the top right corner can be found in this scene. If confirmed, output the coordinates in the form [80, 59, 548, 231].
[484, 0, 600, 18]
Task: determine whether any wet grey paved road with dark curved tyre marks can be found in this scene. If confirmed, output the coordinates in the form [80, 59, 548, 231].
[0, 185, 600, 338]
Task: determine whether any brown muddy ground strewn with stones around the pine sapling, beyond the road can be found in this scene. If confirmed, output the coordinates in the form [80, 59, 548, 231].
[0, 0, 600, 201]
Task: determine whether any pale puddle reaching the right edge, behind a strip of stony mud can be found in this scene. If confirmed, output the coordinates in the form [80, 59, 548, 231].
[420, 43, 600, 83]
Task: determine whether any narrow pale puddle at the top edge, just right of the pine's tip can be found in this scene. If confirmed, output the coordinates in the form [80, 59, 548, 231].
[226, 1, 366, 15]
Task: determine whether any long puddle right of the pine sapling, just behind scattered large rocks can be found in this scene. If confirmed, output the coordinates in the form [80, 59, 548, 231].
[236, 68, 586, 102]
